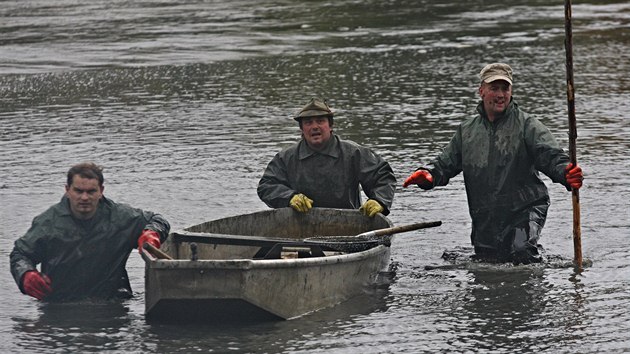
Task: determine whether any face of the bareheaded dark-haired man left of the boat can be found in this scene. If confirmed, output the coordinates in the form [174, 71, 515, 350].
[66, 175, 105, 219]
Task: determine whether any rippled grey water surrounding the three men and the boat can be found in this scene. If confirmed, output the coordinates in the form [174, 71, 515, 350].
[0, 0, 630, 353]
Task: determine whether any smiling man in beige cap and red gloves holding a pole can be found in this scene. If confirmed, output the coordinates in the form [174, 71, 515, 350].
[403, 63, 583, 264]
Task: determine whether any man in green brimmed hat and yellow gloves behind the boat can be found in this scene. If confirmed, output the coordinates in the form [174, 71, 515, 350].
[258, 98, 396, 217]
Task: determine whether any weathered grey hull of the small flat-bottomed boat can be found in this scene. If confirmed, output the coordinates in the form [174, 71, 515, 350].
[143, 208, 391, 322]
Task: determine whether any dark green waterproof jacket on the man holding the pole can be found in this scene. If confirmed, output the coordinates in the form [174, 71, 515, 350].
[426, 101, 570, 250]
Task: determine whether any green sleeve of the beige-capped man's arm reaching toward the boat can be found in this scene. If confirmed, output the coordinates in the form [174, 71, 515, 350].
[420, 126, 462, 186]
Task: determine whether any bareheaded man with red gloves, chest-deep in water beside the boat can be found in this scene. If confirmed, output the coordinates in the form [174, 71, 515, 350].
[10, 162, 170, 302]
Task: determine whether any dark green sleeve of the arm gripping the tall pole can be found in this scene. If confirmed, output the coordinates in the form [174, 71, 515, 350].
[525, 117, 571, 190]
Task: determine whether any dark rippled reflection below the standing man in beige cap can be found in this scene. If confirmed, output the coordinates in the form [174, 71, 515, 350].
[422, 263, 587, 352]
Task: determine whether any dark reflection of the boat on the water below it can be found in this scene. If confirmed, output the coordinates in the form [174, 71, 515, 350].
[143, 265, 395, 353]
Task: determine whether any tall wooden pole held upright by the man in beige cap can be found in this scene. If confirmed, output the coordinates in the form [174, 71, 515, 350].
[564, 0, 582, 269]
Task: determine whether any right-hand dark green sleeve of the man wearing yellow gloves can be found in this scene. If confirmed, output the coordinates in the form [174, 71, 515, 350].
[359, 148, 396, 215]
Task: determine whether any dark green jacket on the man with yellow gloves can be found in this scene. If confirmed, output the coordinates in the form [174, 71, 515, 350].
[258, 135, 396, 215]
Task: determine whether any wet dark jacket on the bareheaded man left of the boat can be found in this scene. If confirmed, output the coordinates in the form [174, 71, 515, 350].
[10, 196, 170, 301]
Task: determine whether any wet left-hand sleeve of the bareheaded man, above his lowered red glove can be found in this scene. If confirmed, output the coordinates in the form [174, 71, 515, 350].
[9, 218, 45, 292]
